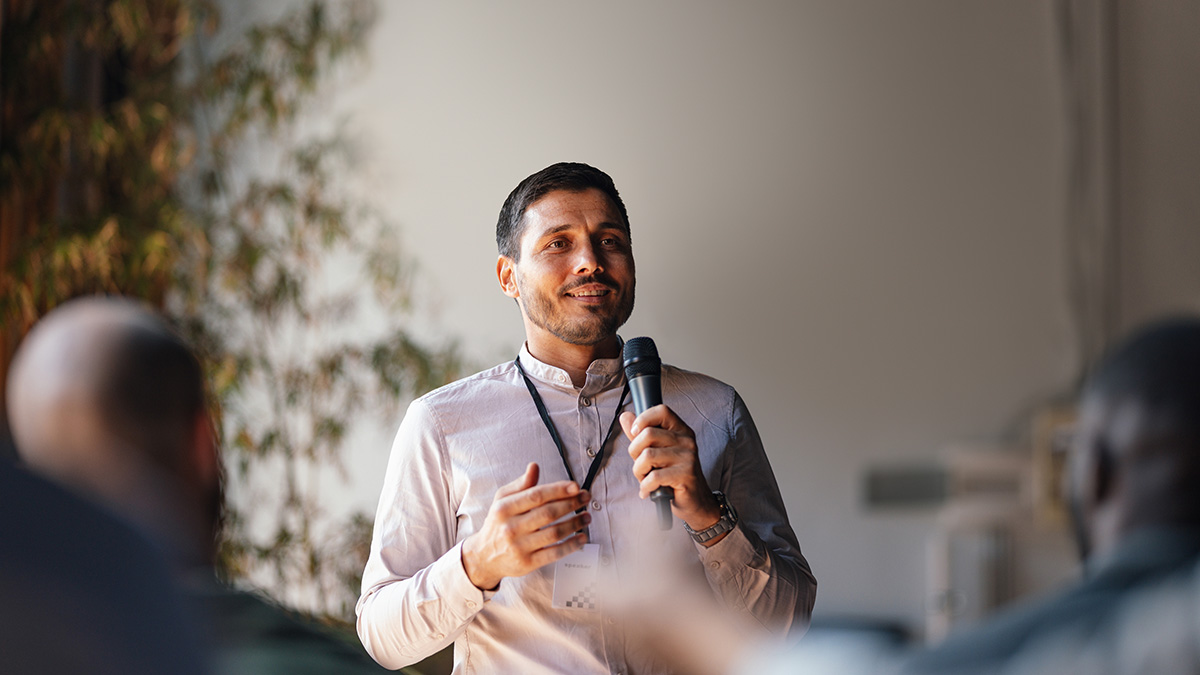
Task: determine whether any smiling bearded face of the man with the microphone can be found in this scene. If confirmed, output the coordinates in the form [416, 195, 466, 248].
[498, 189, 634, 345]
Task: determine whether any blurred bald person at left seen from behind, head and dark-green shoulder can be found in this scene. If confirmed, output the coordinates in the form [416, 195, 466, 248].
[8, 298, 398, 675]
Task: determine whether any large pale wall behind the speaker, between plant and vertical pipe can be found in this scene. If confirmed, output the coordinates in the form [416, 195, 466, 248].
[341, 0, 1078, 628]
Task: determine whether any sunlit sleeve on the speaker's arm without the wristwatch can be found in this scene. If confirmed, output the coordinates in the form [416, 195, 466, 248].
[355, 400, 487, 669]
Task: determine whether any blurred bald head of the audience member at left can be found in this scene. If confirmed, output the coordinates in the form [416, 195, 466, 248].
[8, 298, 221, 565]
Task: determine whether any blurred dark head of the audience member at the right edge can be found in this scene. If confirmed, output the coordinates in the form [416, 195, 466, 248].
[1069, 317, 1200, 556]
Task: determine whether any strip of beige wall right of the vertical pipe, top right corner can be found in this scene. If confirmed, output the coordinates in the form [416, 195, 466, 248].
[1117, 0, 1200, 328]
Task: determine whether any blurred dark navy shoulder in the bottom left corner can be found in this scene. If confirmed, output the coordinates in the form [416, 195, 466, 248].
[0, 435, 210, 675]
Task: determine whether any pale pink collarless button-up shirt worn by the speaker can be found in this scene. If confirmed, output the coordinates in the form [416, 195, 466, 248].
[356, 348, 816, 674]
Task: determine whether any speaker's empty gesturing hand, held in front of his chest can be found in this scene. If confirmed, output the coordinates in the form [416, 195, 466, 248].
[462, 462, 592, 591]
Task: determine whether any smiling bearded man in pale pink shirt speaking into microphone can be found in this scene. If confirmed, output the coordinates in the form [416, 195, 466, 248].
[356, 163, 816, 674]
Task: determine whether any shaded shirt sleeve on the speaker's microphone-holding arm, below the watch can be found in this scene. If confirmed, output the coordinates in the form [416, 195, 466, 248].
[697, 392, 817, 637]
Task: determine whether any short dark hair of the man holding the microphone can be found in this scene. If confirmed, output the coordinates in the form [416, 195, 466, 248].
[496, 162, 629, 261]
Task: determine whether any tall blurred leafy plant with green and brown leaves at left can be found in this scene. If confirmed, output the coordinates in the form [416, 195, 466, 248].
[0, 0, 460, 620]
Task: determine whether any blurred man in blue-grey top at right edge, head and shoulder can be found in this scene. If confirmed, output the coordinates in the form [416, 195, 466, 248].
[904, 318, 1200, 674]
